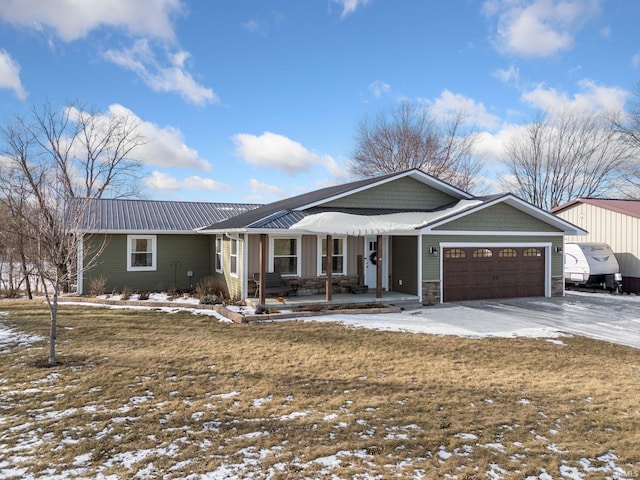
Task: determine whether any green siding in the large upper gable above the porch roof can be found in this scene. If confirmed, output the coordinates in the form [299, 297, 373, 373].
[323, 177, 458, 210]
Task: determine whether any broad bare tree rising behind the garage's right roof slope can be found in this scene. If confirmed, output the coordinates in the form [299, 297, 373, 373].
[501, 109, 630, 210]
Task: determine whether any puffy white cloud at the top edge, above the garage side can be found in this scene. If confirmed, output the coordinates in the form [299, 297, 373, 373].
[483, 0, 600, 57]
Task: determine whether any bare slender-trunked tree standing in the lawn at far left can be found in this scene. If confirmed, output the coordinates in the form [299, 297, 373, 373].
[0, 104, 144, 364]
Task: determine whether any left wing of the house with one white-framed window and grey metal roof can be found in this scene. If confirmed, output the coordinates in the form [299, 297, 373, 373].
[77, 198, 260, 294]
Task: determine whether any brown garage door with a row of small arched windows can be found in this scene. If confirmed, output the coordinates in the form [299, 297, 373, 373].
[442, 247, 545, 302]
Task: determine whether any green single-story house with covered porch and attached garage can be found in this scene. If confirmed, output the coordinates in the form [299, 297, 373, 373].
[78, 169, 586, 304]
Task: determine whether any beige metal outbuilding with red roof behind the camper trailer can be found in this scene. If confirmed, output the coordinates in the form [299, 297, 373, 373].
[551, 198, 640, 293]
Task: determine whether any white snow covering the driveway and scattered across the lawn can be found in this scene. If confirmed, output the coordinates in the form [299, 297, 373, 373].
[0, 295, 640, 480]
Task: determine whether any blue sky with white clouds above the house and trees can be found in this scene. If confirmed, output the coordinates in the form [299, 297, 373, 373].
[0, 0, 640, 202]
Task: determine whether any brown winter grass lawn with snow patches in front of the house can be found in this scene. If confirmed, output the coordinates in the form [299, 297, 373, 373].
[0, 301, 640, 479]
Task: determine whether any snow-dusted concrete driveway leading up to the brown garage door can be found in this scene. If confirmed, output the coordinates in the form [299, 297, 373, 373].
[306, 292, 640, 348]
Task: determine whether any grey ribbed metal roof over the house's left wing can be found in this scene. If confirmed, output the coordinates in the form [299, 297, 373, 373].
[76, 198, 260, 232]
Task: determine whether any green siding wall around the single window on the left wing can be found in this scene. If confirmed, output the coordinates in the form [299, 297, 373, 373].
[83, 235, 211, 294]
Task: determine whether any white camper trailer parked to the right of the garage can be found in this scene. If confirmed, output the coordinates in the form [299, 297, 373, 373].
[564, 243, 622, 292]
